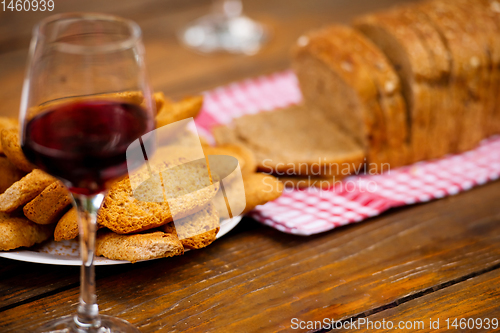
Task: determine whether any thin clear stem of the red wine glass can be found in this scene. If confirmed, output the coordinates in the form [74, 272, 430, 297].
[73, 194, 104, 332]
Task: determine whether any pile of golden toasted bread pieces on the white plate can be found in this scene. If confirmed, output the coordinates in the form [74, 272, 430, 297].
[0, 93, 283, 262]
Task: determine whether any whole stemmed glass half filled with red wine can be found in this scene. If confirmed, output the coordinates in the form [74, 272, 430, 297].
[20, 13, 155, 333]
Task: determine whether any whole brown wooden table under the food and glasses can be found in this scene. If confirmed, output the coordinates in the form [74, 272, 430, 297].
[0, 0, 500, 333]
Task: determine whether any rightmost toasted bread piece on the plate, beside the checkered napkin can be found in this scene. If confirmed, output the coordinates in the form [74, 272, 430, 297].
[242, 173, 283, 214]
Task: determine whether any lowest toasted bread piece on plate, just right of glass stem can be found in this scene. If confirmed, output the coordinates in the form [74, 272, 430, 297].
[95, 230, 184, 263]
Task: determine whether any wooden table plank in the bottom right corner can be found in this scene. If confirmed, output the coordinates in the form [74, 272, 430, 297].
[335, 269, 500, 332]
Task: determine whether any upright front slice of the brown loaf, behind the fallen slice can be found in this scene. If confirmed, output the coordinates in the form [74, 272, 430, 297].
[293, 25, 389, 169]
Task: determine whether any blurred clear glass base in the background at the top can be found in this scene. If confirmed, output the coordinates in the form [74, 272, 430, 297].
[179, 14, 269, 55]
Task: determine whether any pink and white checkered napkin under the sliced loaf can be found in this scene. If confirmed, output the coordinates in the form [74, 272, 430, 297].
[196, 71, 500, 235]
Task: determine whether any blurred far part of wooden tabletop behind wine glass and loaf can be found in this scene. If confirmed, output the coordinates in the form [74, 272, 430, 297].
[0, 0, 418, 117]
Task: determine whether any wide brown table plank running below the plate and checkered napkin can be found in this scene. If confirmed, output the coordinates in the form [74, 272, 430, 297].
[0, 181, 500, 332]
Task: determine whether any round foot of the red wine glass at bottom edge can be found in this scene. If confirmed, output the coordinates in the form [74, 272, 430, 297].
[35, 315, 140, 333]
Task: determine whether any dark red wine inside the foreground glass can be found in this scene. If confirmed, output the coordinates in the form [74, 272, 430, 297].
[22, 100, 154, 195]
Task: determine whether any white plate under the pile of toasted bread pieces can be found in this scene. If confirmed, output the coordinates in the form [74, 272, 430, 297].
[0, 216, 241, 266]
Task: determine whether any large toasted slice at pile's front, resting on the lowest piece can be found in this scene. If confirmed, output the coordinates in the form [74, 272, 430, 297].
[98, 155, 219, 234]
